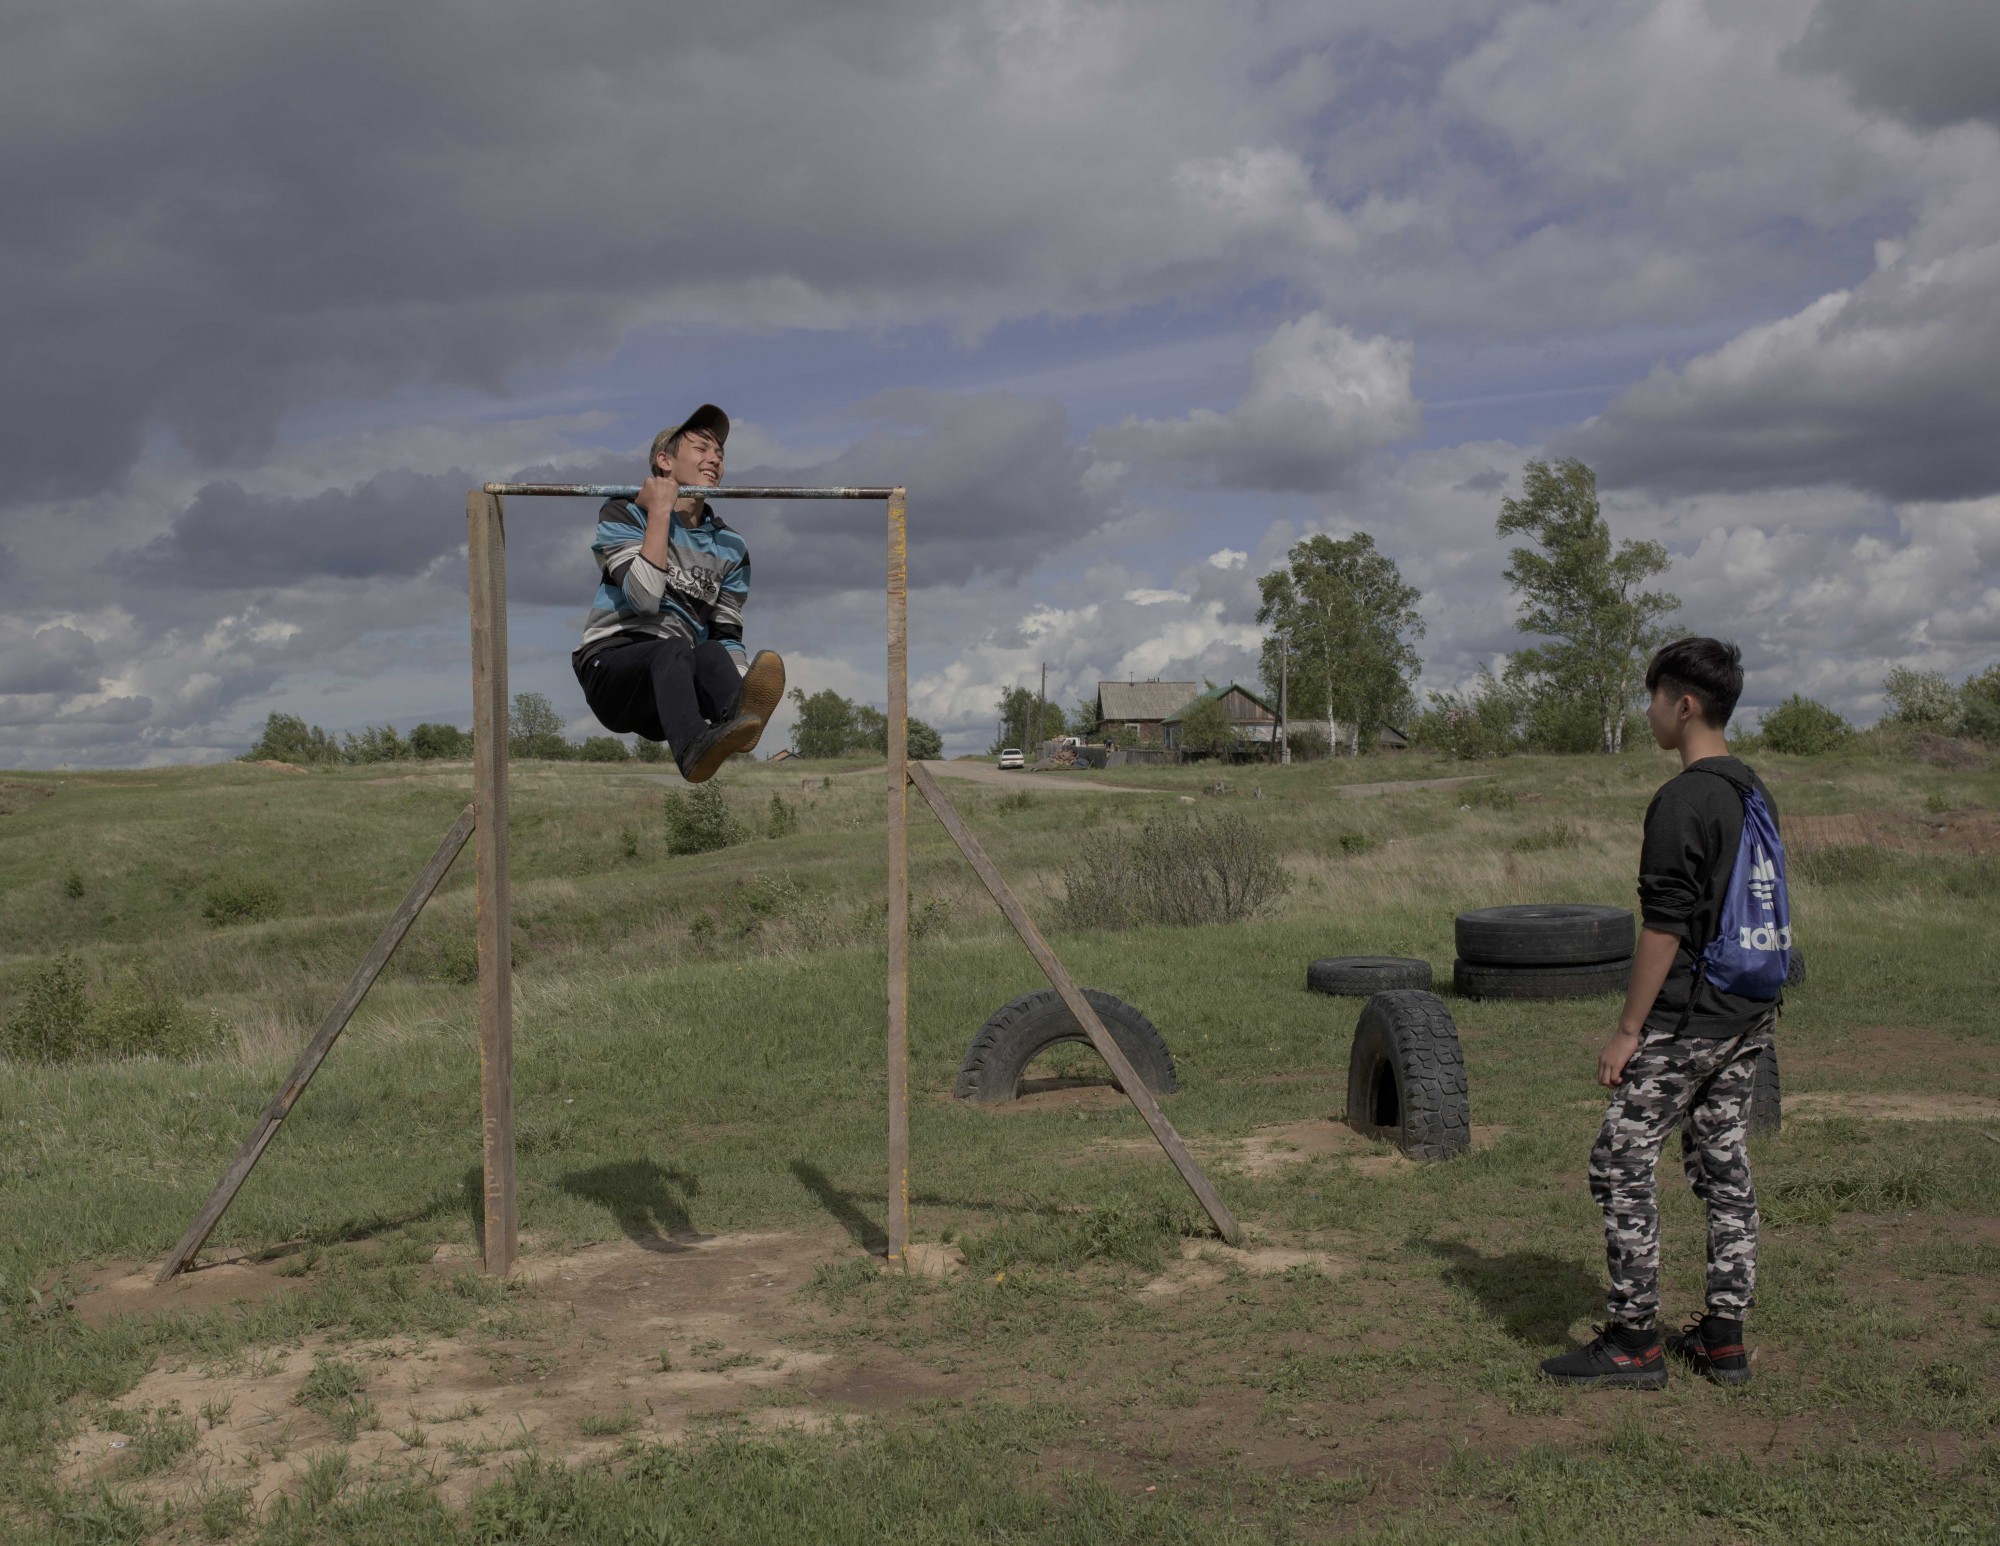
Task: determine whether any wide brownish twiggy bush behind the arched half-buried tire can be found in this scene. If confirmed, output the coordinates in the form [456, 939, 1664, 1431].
[1056, 812, 1292, 928]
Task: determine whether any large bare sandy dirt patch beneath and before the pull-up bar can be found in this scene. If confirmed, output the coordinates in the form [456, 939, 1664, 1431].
[62, 1234, 964, 1504]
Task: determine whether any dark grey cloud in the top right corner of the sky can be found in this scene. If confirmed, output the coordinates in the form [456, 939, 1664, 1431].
[1792, 0, 2000, 128]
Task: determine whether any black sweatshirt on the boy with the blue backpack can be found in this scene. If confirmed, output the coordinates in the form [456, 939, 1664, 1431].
[1638, 756, 1782, 1036]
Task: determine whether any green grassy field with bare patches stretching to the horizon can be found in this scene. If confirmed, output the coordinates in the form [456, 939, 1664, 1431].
[0, 740, 2000, 1542]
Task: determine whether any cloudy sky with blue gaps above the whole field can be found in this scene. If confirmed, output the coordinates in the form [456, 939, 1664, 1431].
[0, 0, 2000, 766]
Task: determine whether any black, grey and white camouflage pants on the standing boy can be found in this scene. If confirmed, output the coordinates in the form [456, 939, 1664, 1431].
[1590, 1016, 1776, 1326]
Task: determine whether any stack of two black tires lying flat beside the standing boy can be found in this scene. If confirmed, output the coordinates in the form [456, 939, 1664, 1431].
[1452, 902, 1636, 998]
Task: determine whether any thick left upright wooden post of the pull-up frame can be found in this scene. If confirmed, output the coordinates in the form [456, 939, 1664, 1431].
[466, 488, 518, 1276]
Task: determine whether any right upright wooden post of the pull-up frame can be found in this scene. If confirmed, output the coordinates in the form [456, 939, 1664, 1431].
[888, 488, 910, 1266]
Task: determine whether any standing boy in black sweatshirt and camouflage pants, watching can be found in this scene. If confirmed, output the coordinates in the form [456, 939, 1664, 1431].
[1542, 638, 1790, 1390]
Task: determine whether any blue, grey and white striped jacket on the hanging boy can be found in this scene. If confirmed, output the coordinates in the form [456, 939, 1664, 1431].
[574, 500, 750, 670]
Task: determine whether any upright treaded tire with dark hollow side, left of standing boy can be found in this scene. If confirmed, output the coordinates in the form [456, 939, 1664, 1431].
[1346, 988, 1472, 1160]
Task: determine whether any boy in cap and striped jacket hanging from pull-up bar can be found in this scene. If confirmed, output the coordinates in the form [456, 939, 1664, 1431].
[570, 402, 784, 784]
